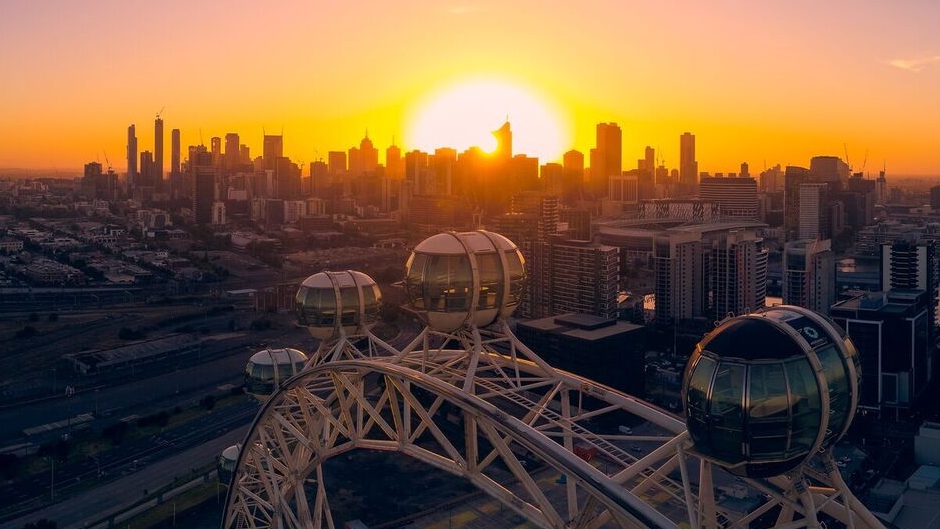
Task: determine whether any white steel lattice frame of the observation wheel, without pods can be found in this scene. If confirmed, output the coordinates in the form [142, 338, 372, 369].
[222, 325, 882, 529]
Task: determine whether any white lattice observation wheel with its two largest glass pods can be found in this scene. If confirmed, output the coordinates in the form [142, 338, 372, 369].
[222, 232, 882, 529]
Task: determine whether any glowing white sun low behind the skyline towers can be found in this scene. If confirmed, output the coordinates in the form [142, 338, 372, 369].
[405, 80, 569, 163]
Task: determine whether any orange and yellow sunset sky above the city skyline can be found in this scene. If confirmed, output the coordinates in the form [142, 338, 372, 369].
[0, 0, 940, 176]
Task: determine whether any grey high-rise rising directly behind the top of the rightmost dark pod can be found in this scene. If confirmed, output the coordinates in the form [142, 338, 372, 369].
[782, 239, 836, 316]
